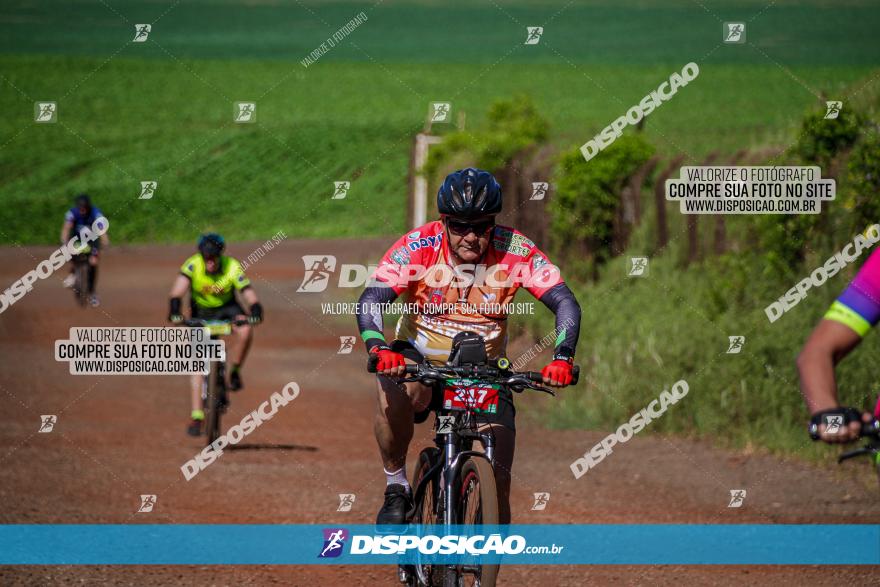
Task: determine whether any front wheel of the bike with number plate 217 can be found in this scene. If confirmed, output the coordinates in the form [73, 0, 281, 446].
[453, 457, 498, 587]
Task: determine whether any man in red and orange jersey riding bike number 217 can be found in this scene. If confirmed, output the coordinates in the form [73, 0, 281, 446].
[357, 168, 581, 525]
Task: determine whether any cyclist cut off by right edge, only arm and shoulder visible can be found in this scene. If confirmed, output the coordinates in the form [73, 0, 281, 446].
[797, 250, 880, 443]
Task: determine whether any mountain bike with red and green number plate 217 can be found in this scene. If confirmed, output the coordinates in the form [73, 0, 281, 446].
[368, 335, 580, 587]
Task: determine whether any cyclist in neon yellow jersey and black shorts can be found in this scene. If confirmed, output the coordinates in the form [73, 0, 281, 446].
[168, 233, 263, 436]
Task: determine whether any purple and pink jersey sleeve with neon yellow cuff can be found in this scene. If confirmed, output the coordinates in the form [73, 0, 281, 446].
[825, 249, 880, 336]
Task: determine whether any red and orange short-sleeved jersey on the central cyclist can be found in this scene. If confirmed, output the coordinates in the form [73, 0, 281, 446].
[375, 220, 562, 361]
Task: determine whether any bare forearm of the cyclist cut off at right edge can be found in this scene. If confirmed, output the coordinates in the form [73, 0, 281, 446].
[797, 320, 861, 414]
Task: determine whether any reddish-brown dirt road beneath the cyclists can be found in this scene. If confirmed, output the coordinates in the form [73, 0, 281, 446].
[0, 239, 880, 585]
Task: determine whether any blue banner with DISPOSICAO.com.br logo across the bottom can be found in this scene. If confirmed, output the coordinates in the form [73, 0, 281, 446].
[0, 524, 880, 565]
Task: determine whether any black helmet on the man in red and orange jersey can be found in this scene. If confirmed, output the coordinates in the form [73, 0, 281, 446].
[437, 167, 501, 218]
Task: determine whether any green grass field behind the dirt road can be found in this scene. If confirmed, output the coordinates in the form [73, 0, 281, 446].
[0, 1, 880, 243]
